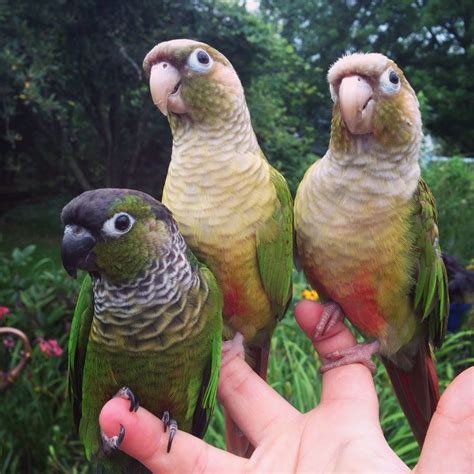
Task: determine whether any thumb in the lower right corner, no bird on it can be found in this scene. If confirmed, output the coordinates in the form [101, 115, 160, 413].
[415, 367, 474, 473]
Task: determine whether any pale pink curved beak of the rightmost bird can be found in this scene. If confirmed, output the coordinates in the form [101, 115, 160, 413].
[339, 76, 375, 135]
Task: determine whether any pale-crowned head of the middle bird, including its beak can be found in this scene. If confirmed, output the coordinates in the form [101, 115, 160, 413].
[143, 39, 245, 122]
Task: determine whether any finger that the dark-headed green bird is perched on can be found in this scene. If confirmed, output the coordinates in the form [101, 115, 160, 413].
[99, 398, 246, 473]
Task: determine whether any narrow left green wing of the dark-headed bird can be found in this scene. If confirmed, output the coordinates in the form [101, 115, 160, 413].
[68, 275, 94, 429]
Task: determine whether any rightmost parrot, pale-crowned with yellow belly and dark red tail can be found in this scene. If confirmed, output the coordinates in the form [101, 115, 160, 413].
[294, 53, 449, 446]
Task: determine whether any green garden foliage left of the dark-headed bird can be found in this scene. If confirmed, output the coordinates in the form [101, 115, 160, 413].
[0, 245, 84, 473]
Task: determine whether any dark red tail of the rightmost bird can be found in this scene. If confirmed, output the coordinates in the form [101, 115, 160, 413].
[382, 340, 439, 447]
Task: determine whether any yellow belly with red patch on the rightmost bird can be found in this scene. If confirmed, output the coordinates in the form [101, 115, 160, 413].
[295, 161, 416, 353]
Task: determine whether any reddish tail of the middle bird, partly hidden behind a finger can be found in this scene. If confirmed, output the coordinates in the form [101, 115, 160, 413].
[224, 347, 269, 458]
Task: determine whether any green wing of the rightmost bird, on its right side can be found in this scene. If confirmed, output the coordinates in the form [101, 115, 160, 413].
[413, 178, 449, 347]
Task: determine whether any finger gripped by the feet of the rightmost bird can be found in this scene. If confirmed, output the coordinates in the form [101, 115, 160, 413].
[295, 300, 378, 408]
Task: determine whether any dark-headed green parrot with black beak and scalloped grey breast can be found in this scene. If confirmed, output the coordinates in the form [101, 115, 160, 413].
[61, 188, 223, 473]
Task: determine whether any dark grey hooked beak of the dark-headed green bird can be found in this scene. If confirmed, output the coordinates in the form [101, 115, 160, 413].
[61, 225, 97, 278]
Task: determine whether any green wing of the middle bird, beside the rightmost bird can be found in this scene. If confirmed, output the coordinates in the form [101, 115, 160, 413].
[257, 167, 294, 319]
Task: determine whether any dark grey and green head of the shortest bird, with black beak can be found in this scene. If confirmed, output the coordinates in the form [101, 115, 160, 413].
[61, 189, 176, 281]
